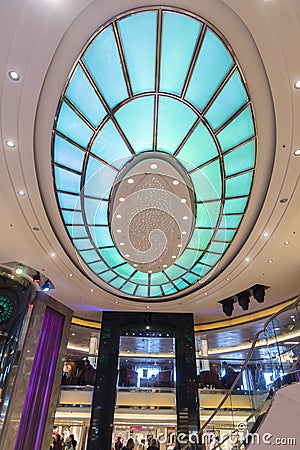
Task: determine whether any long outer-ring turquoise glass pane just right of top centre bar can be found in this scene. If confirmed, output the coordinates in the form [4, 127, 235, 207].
[160, 12, 202, 95]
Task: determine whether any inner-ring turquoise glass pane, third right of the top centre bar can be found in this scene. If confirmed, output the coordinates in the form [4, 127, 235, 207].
[191, 160, 222, 202]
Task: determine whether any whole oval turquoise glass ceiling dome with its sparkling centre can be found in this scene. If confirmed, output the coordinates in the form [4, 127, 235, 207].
[52, 8, 256, 301]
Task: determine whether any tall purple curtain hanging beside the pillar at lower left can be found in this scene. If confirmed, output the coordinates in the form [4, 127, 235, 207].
[14, 306, 65, 450]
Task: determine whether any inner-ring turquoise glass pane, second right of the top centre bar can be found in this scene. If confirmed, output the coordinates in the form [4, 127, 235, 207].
[177, 122, 218, 171]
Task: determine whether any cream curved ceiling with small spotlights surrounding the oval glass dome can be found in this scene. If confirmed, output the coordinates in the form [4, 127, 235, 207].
[0, 0, 300, 323]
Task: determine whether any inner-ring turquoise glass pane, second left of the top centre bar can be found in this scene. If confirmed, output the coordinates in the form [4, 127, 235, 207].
[91, 120, 132, 169]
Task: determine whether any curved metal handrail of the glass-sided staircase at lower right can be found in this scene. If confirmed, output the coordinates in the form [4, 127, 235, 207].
[188, 295, 300, 450]
